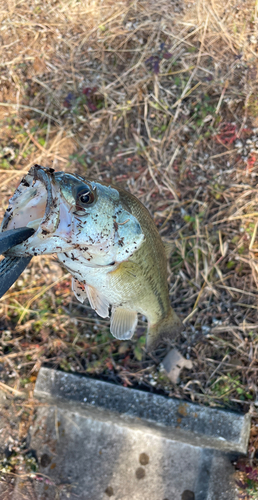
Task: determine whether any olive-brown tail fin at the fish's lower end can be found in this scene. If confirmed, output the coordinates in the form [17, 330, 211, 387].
[146, 308, 183, 351]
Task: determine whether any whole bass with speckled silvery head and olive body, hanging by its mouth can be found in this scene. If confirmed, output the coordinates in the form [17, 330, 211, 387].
[0, 165, 182, 351]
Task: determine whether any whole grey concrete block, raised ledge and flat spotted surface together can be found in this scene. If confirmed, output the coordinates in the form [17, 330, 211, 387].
[23, 368, 249, 500]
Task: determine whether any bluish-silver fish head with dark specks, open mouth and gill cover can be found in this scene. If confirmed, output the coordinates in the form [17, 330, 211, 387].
[0, 165, 144, 267]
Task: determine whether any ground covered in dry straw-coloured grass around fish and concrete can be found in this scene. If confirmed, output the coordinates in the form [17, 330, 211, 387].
[0, 0, 258, 500]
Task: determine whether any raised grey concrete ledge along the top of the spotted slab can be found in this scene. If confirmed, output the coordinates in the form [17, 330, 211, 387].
[34, 368, 250, 453]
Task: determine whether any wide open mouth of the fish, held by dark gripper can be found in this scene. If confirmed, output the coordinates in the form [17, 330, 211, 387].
[0, 164, 55, 232]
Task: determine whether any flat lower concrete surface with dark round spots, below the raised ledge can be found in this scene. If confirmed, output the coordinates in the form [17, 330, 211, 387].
[26, 405, 237, 500]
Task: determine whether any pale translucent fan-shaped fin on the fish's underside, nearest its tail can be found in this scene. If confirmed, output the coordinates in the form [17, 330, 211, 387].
[110, 306, 138, 340]
